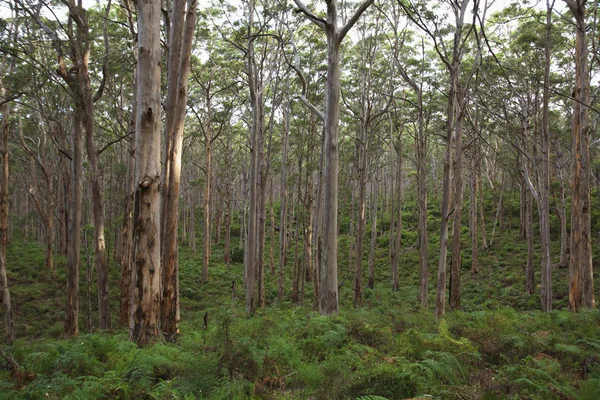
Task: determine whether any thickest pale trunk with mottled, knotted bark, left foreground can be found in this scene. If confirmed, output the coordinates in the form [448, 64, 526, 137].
[130, 0, 161, 346]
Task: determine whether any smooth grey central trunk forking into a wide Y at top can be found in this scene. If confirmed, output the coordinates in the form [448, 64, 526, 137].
[294, 0, 373, 315]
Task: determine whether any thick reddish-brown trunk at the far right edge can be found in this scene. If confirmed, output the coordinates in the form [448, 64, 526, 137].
[564, 0, 594, 311]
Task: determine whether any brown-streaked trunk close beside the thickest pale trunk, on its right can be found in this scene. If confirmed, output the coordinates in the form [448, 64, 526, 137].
[159, 0, 196, 342]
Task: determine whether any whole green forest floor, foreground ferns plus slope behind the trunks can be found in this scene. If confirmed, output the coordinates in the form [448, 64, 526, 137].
[0, 220, 600, 400]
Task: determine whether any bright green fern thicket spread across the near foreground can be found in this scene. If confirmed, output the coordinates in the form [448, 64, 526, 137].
[0, 306, 600, 400]
